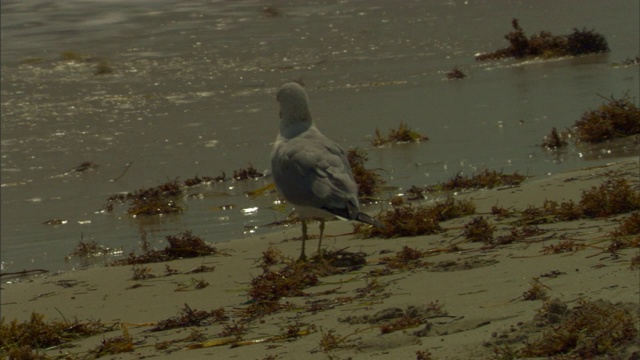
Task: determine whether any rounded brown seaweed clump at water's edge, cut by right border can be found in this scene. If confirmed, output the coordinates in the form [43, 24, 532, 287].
[574, 96, 640, 143]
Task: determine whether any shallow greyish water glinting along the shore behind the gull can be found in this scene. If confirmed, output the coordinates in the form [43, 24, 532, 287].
[0, 0, 640, 272]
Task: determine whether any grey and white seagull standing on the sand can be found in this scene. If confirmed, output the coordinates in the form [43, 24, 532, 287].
[271, 82, 384, 260]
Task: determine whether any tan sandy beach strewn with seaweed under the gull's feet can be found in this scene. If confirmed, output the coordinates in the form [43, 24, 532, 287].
[2, 158, 640, 359]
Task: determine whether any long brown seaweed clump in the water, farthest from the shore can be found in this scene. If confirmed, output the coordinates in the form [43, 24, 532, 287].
[476, 19, 609, 61]
